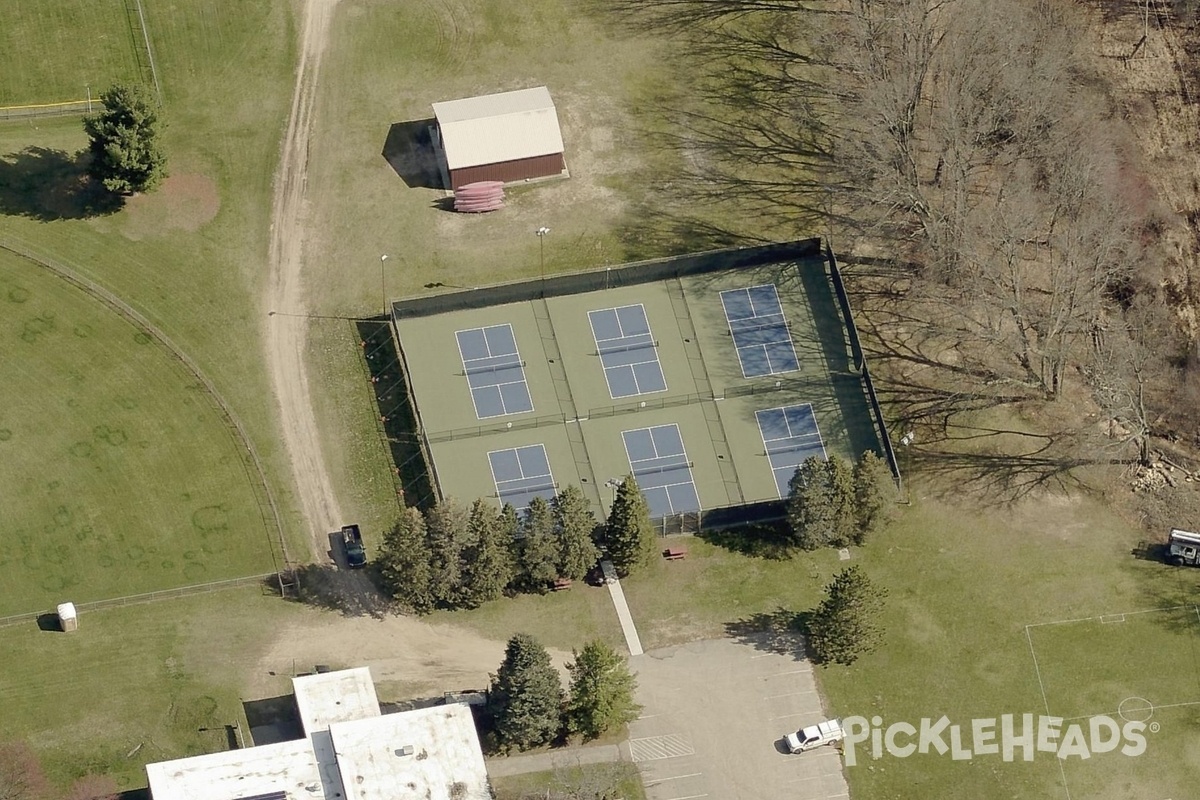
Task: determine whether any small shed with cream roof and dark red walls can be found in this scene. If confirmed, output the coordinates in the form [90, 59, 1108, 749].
[433, 86, 566, 190]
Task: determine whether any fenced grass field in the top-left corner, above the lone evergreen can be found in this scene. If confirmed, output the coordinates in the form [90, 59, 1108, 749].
[0, 0, 151, 106]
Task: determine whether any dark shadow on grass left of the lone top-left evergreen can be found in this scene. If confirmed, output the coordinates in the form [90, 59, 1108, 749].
[0, 146, 125, 222]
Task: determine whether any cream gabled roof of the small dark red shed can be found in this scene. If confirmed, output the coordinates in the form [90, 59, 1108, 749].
[433, 86, 563, 169]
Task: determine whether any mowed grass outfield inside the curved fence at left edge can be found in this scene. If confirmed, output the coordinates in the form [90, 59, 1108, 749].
[0, 251, 277, 616]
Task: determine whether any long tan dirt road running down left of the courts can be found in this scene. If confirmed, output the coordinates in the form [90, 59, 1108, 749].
[264, 0, 342, 559]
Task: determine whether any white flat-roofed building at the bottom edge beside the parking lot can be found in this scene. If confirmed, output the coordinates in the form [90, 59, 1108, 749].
[146, 667, 492, 800]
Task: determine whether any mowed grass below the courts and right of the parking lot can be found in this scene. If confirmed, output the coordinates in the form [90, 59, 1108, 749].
[623, 476, 1200, 800]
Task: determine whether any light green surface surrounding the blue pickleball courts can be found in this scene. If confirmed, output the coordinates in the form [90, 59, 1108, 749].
[396, 247, 878, 522]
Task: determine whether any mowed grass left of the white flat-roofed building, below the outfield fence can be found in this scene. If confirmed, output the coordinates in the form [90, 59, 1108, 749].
[0, 587, 314, 789]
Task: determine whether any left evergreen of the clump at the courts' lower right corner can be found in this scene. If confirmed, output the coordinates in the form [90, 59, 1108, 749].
[787, 456, 856, 551]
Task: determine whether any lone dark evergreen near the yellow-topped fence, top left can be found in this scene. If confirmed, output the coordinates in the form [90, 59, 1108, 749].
[83, 84, 167, 194]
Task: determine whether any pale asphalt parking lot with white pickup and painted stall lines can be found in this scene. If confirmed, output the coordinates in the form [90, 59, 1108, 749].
[629, 639, 850, 800]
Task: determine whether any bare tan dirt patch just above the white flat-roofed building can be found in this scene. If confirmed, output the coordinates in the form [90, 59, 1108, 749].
[246, 615, 571, 702]
